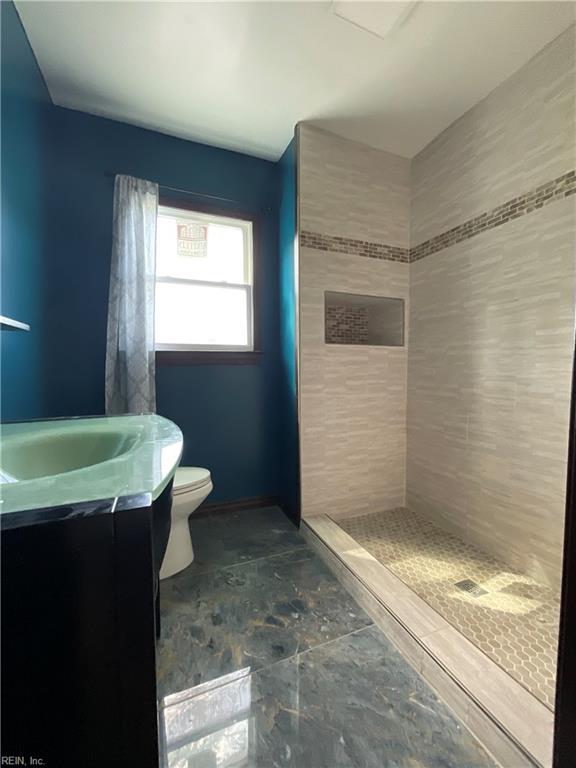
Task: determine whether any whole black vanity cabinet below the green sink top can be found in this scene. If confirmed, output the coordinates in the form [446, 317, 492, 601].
[1, 480, 171, 768]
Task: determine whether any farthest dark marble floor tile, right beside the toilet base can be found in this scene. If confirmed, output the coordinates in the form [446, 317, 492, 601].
[190, 507, 306, 573]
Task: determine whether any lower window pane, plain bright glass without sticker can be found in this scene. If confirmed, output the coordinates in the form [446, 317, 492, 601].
[155, 283, 252, 347]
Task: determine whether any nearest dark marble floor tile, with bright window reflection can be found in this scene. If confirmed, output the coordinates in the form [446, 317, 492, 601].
[161, 626, 496, 768]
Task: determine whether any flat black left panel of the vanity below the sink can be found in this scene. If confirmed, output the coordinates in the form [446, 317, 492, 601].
[2, 514, 120, 768]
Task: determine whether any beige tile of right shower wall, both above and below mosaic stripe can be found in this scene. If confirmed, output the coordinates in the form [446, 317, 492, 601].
[407, 27, 576, 584]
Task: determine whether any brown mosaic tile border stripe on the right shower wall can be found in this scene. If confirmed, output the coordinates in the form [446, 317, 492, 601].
[410, 170, 576, 262]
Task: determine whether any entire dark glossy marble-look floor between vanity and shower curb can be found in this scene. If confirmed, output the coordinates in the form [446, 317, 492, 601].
[157, 508, 495, 768]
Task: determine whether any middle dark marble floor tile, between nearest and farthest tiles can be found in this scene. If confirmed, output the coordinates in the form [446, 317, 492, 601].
[158, 549, 371, 697]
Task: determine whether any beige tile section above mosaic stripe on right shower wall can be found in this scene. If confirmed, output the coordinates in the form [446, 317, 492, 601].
[410, 26, 576, 246]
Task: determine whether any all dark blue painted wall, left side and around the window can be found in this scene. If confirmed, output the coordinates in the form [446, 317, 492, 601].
[2, 2, 302, 510]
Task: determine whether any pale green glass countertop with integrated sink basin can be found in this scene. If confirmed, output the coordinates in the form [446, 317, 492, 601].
[0, 414, 182, 522]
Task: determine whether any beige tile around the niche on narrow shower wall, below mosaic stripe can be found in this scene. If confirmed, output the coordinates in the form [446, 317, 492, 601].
[300, 248, 409, 516]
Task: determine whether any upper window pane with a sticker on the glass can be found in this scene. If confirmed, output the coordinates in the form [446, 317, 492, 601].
[156, 213, 252, 284]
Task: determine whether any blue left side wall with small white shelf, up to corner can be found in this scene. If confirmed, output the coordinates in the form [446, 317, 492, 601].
[0, 2, 51, 419]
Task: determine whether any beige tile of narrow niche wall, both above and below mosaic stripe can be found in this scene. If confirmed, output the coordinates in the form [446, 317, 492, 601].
[299, 125, 409, 516]
